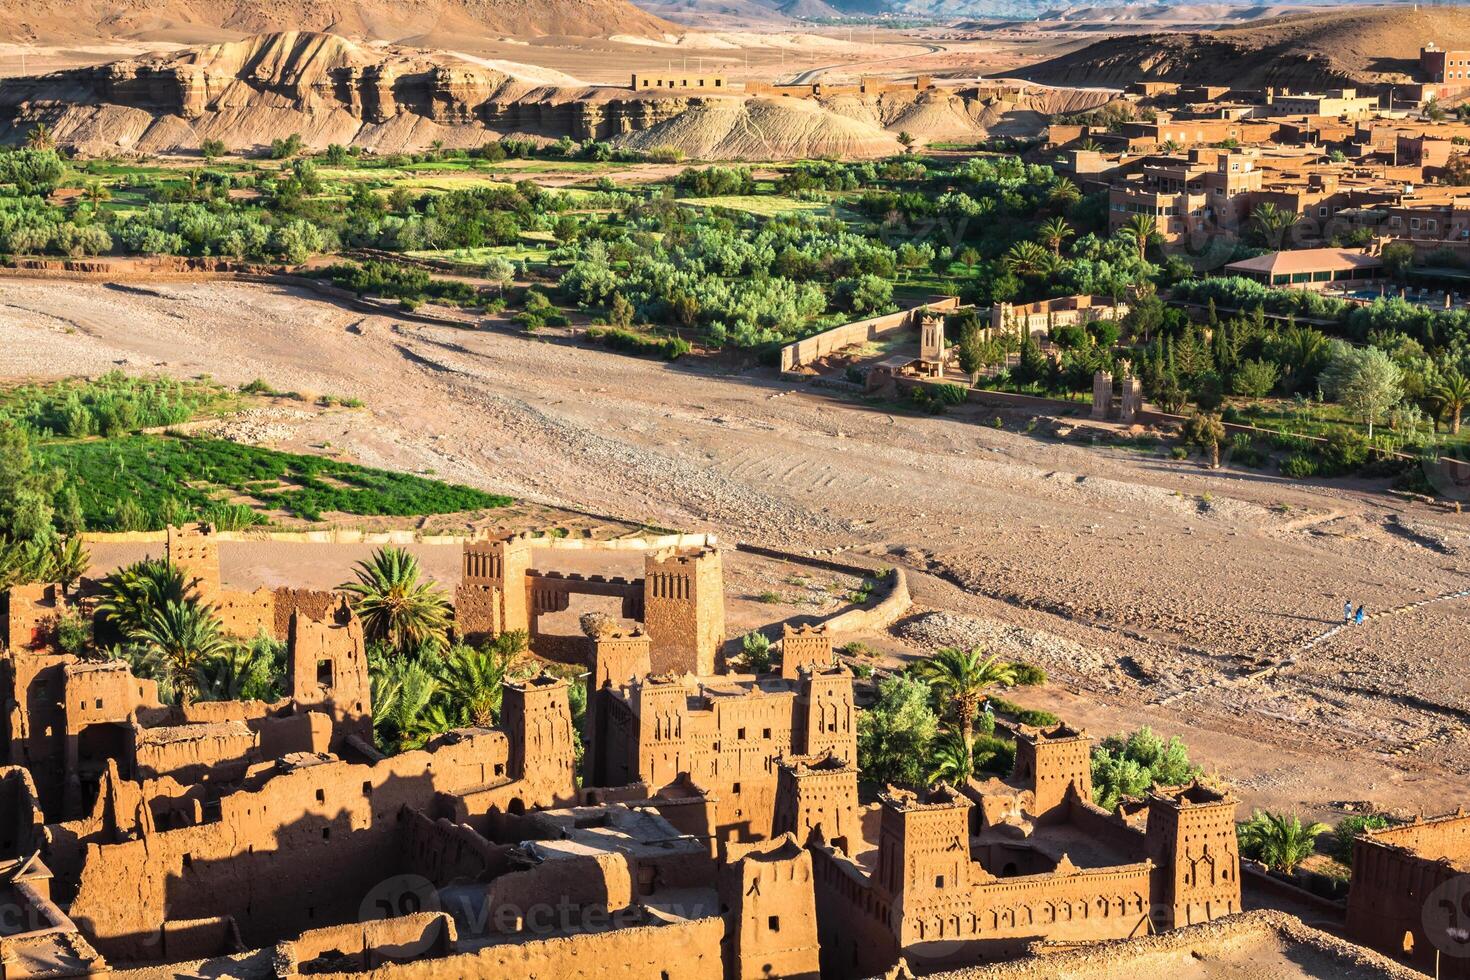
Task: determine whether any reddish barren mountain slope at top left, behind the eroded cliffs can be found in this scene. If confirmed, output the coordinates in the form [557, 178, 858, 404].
[0, 0, 676, 43]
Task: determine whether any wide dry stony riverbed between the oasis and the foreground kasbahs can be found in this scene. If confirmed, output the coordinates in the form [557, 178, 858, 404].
[0, 279, 1470, 815]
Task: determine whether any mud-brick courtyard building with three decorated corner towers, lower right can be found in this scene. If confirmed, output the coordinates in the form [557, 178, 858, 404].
[811, 726, 1241, 976]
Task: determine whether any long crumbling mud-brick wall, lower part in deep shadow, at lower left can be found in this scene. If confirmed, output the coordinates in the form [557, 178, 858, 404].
[60, 721, 558, 958]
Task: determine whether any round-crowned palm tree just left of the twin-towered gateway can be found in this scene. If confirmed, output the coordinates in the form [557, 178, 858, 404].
[341, 548, 450, 652]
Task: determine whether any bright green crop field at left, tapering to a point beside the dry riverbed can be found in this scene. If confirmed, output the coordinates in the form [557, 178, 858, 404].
[37, 435, 512, 530]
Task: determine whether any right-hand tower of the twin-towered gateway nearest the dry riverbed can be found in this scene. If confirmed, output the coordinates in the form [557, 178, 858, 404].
[644, 548, 725, 677]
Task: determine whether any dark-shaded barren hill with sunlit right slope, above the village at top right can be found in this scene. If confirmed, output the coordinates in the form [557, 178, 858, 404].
[1019, 6, 1470, 88]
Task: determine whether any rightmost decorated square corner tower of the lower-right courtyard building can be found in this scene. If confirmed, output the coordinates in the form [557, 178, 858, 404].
[1145, 782, 1241, 929]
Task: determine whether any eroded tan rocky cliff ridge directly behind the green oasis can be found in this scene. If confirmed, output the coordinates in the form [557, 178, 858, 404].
[0, 31, 1107, 160]
